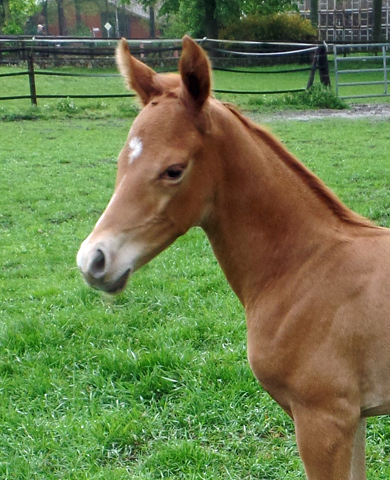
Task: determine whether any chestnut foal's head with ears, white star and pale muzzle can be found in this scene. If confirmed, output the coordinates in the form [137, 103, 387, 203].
[77, 37, 216, 293]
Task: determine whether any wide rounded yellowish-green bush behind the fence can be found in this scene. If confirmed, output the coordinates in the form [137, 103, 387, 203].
[219, 13, 317, 42]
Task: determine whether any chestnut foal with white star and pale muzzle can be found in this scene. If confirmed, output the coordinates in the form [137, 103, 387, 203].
[77, 37, 390, 480]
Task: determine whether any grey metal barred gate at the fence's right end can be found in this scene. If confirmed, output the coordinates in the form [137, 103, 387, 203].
[333, 44, 390, 99]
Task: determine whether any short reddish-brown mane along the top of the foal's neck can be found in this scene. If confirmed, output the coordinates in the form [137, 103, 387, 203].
[224, 103, 375, 227]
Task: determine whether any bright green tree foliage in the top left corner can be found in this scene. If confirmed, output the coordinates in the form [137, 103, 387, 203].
[0, 0, 39, 35]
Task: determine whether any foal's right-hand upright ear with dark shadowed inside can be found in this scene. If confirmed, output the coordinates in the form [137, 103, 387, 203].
[179, 35, 211, 108]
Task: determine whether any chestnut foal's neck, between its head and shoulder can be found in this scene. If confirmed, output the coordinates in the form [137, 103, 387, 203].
[203, 107, 370, 307]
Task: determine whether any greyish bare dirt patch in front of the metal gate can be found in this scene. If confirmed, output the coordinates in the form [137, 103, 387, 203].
[251, 103, 390, 122]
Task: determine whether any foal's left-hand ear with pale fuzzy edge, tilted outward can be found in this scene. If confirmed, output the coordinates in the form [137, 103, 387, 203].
[115, 38, 162, 105]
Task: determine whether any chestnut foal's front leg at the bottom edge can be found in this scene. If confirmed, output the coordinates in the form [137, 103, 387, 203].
[294, 408, 366, 480]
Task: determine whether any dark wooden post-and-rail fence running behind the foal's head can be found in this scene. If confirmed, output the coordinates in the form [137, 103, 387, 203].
[0, 37, 330, 105]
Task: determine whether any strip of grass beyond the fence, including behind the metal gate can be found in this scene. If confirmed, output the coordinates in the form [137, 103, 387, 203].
[0, 50, 389, 120]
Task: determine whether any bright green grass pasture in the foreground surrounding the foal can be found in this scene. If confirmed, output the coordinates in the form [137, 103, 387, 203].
[0, 113, 390, 480]
